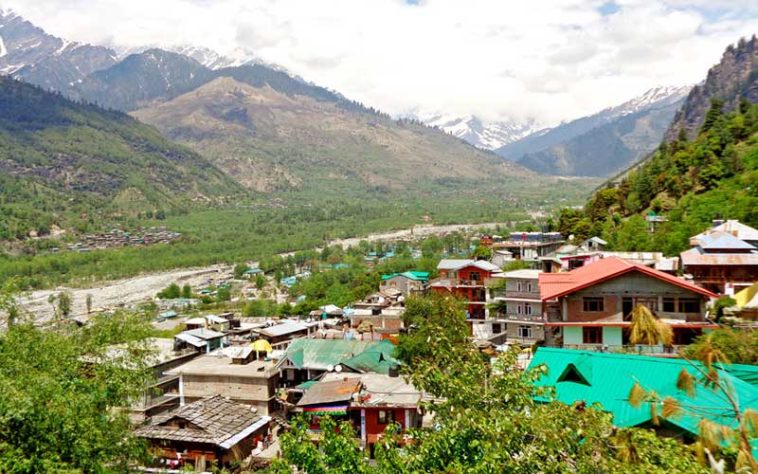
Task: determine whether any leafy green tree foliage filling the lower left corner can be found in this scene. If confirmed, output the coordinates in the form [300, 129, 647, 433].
[0, 315, 149, 473]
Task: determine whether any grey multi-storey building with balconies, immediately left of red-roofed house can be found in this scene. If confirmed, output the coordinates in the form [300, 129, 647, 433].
[490, 269, 545, 344]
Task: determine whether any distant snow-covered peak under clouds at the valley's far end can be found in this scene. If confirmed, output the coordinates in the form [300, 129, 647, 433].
[414, 114, 542, 150]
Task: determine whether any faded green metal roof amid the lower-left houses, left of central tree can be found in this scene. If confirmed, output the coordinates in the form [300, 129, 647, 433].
[285, 338, 394, 370]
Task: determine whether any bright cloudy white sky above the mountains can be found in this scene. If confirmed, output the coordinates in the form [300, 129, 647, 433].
[0, 0, 758, 123]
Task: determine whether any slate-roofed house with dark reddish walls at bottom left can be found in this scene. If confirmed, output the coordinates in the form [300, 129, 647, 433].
[135, 395, 271, 471]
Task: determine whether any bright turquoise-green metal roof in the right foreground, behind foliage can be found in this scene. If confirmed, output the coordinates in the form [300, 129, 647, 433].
[530, 347, 758, 435]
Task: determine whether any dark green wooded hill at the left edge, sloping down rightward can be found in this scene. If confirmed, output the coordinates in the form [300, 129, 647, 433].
[0, 77, 241, 236]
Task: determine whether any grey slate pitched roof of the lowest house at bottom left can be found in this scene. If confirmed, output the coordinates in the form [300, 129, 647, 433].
[135, 395, 271, 449]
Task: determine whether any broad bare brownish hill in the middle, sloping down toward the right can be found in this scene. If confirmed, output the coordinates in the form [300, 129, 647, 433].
[134, 77, 530, 191]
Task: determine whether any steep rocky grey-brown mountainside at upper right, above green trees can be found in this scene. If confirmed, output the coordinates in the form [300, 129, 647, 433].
[666, 35, 758, 142]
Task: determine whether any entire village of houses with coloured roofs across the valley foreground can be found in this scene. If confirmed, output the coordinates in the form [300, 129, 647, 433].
[68, 220, 758, 472]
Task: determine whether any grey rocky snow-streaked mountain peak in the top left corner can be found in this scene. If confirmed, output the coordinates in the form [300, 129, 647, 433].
[0, 11, 116, 90]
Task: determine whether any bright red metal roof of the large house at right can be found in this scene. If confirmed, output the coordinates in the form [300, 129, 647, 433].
[539, 257, 716, 301]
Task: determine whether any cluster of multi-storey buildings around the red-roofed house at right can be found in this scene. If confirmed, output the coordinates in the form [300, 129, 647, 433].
[430, 221, 758, 351]
